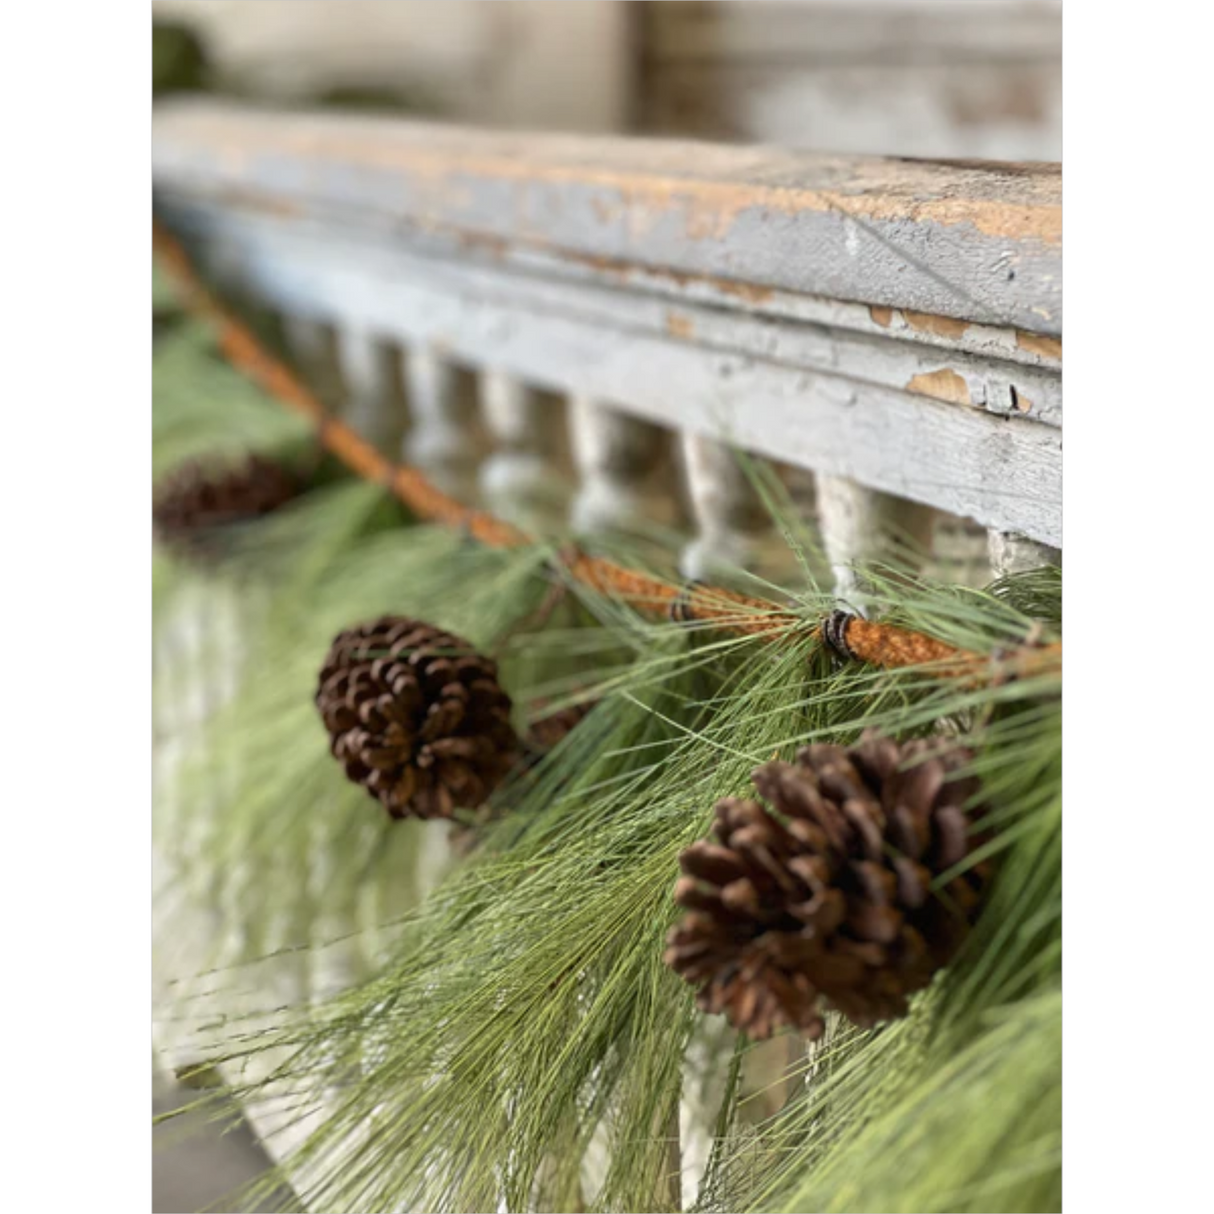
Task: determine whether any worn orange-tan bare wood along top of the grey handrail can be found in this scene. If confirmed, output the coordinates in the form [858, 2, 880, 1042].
[155, 110, 1062, 248]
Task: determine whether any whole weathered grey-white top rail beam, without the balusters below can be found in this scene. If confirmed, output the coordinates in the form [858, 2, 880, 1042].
[153, 104, 1062, 546]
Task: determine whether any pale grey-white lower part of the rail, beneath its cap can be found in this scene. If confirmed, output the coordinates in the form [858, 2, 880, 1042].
[154, 191, 1062, 544]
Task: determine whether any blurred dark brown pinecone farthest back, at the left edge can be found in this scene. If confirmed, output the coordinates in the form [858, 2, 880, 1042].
[152, 455, 302, 552]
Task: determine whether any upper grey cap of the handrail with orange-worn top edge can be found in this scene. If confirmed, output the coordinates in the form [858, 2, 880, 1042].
[153, 101, 1062, 340]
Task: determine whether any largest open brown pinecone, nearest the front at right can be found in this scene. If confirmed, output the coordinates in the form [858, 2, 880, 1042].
[665, 734, 988, 1038]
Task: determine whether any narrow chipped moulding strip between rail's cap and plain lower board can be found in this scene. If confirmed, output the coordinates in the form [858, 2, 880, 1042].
[163, 195, 1062, 427]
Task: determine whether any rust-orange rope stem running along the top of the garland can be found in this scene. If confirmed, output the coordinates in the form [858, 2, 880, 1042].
[152, 220, 1062, 682]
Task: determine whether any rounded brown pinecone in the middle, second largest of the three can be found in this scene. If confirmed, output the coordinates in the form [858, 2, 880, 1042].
[316, 615, 520, 818]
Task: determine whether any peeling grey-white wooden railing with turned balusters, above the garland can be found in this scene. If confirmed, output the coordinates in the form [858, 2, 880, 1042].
[153, 101, 1062, 587]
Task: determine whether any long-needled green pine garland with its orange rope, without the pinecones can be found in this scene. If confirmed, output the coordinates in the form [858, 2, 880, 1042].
[155, 220, 1061, 1212]
